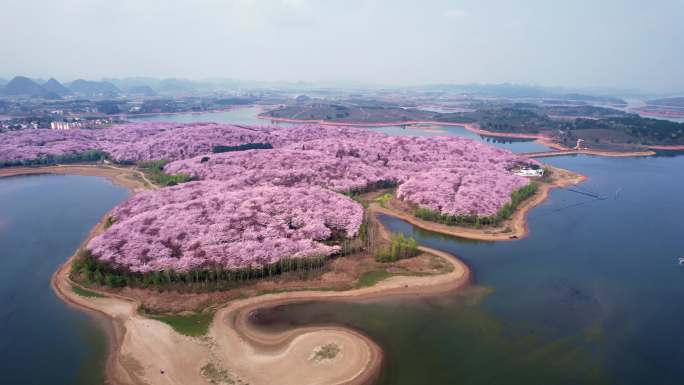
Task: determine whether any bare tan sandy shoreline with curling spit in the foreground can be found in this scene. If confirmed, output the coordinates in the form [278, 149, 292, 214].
[52, 216, 470, 385]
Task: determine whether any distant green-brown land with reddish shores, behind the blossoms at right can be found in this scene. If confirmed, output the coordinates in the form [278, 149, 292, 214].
[260, 101, 684, 156]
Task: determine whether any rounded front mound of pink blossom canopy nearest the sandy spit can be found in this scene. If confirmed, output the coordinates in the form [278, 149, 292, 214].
[88, 181, 363, 273]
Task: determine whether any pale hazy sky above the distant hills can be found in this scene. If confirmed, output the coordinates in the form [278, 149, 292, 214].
[0, 0, 684, 92]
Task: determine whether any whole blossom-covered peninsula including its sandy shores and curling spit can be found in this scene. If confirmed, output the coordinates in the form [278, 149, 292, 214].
[0, 123, 583, 384]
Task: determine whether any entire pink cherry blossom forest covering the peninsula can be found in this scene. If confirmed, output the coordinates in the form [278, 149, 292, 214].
[0, 122, 535, 273]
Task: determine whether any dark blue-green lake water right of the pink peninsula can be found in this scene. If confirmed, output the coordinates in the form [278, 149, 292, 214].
[251, 156, 684, 385]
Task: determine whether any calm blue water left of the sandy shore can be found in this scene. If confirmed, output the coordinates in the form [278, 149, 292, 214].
[0, 175, 128, 385]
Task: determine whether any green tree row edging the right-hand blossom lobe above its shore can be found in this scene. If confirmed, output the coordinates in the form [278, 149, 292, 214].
[413, 182, 539, 227]
